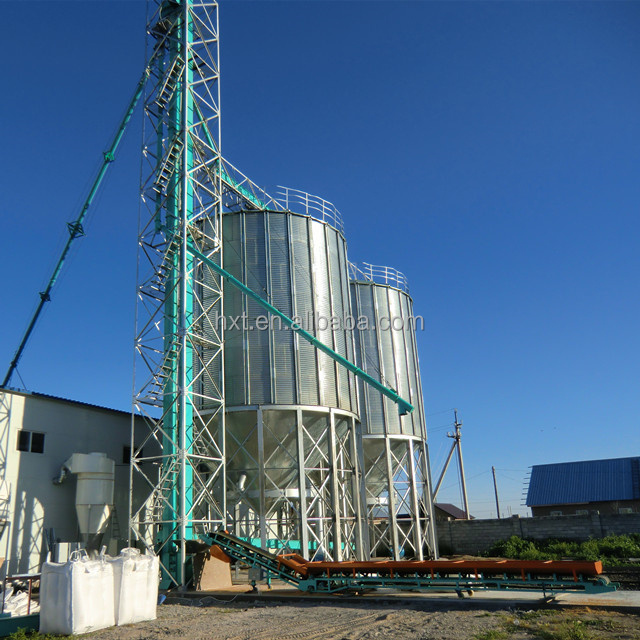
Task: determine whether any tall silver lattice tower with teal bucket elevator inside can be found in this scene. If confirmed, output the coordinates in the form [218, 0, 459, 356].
[130, 0, 226, 586]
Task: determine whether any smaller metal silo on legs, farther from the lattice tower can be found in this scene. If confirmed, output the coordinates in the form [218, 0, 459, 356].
[350, 264, 437, 559]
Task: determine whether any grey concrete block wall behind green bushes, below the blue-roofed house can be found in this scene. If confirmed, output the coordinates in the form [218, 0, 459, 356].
[436, 513, 640, 555]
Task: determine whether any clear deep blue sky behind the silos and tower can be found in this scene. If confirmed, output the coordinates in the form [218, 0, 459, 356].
[0, 0, 640, 516]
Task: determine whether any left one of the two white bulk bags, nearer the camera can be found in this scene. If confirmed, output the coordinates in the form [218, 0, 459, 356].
[40, 552, 115, 635]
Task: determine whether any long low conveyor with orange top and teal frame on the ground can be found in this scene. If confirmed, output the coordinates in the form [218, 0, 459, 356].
[211, 531, 618, 597]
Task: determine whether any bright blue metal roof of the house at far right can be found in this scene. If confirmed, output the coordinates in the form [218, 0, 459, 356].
[527, 457, 640, 507]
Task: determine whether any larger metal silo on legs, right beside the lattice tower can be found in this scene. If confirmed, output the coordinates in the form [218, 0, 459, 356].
[223, 190, 365, 560]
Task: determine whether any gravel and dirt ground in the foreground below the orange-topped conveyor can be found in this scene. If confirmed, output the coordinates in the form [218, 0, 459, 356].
[90, 597, 640, 640]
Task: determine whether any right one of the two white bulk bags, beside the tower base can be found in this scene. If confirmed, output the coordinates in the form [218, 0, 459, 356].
[109, 548, 160, 625]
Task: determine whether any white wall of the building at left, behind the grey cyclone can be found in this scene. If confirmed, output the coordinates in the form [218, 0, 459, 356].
[0, 391, 149, 575]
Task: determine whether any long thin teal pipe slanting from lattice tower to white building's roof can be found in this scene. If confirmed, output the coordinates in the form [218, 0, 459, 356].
[0, 66, 150, 388]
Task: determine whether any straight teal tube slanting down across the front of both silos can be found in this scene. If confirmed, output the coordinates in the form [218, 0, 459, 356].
[189, 244, 413, 416]
